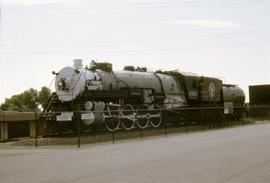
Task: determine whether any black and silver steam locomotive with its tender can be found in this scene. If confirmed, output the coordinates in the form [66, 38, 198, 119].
[41, 59, 245, 131]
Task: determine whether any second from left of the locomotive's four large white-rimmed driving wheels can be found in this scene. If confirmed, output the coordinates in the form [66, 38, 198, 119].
[120, 104, 136, 130]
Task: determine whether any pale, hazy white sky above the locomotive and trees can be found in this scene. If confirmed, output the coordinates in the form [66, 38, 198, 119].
[0, 0, 270, 103]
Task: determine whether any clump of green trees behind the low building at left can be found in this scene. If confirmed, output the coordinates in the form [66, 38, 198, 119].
[0, 87, 51, 112]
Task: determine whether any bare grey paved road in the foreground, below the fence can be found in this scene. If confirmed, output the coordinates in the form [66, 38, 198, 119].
[0, 124, 270, 183]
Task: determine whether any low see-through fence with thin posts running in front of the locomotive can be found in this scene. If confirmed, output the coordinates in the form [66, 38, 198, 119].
[0, 106, 270, 148]
